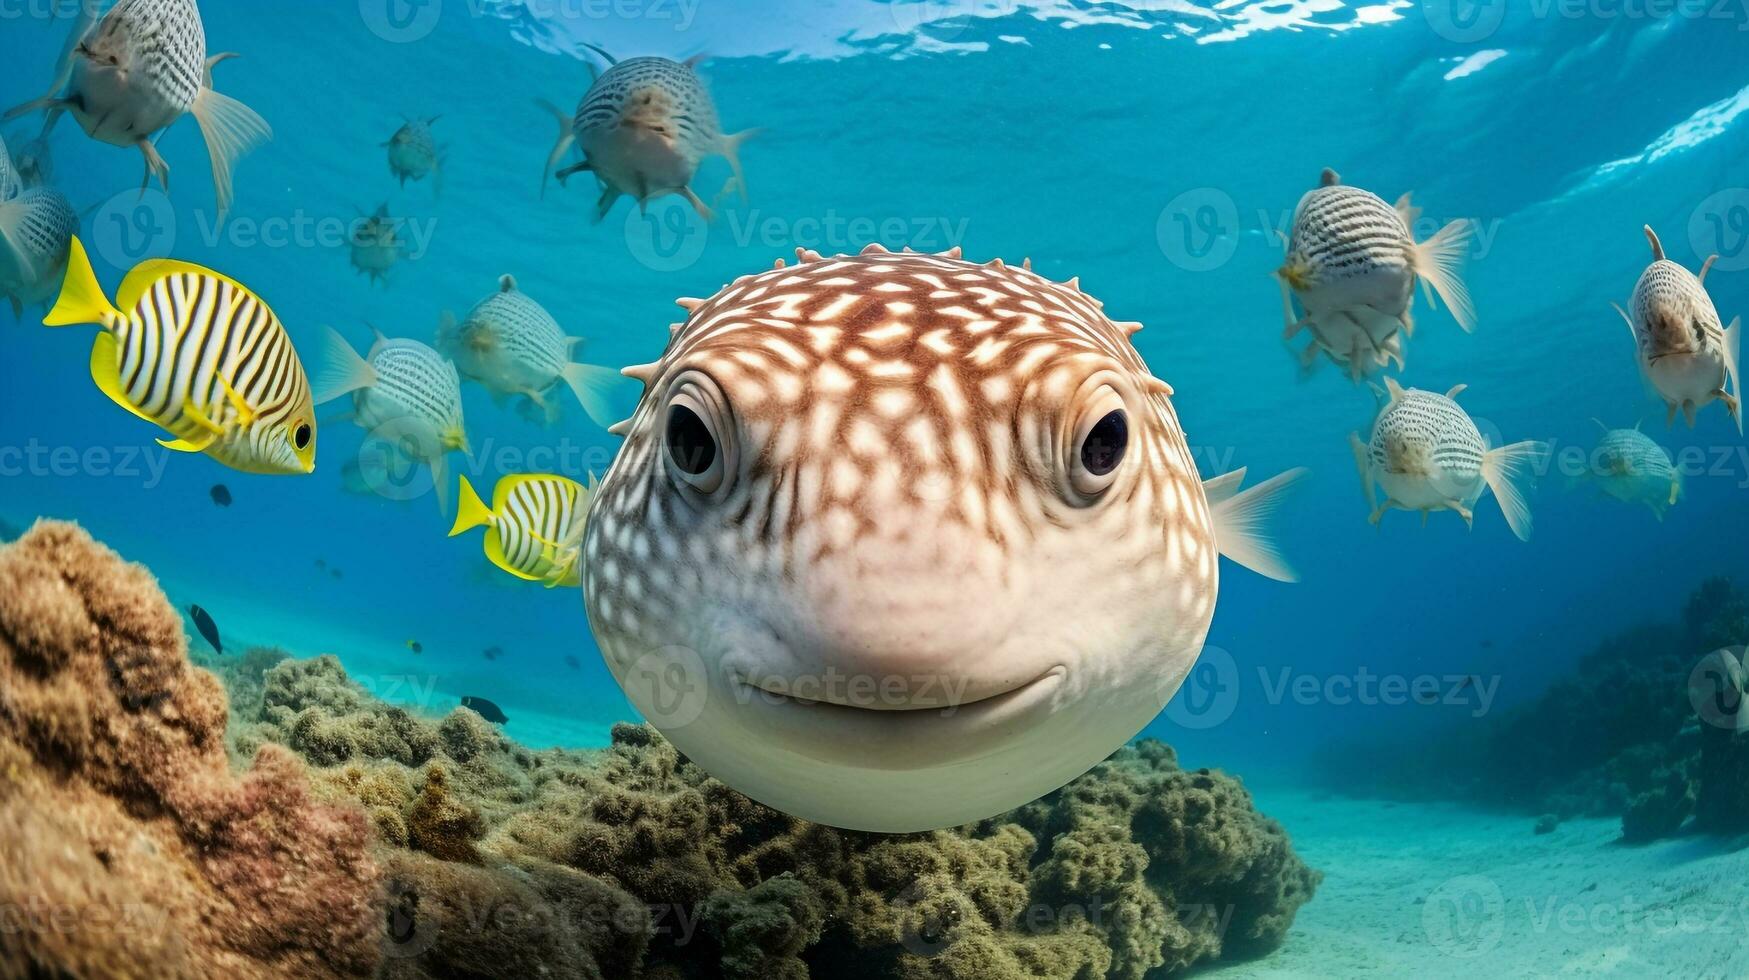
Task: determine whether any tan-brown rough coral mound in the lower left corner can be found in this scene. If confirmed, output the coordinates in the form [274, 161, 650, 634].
[0, 522, 381, 978]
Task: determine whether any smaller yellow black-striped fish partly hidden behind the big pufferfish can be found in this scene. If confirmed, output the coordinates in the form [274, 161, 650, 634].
[449, 473, 589, 588]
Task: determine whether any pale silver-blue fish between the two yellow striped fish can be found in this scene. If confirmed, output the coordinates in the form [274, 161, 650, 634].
[315, 327, 469, 513]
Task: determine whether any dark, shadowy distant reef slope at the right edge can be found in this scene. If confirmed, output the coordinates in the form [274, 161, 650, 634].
[1331, 578, 1749, 842]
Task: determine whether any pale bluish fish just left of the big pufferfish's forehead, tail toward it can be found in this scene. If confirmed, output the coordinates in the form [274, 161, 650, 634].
[437, 275, 619, 427]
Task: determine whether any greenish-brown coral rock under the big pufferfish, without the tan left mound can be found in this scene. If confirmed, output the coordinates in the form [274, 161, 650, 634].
[243, 658, 1319, 980]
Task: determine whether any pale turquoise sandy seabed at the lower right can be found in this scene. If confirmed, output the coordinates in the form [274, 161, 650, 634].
[1209, 786, 1749, 980]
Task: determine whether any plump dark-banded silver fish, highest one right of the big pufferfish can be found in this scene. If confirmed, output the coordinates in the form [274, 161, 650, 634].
[1275, 168, 1476, 380]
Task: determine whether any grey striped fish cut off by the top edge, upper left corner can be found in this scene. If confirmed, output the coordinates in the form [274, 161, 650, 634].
[5, 0, 273, 214]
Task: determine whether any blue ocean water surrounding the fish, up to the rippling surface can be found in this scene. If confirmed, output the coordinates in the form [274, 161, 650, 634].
[0, 0, 1749, 779]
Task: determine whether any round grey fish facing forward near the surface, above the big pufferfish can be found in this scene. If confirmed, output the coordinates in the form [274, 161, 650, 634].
[540, 46, 756, 221]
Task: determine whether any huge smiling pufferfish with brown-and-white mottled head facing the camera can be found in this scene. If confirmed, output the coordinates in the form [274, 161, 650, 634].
[582, 247, 1303, 831]
